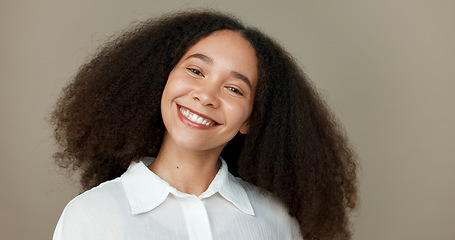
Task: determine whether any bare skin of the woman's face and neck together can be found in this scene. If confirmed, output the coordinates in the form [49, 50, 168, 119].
[149, 30, 258, 196]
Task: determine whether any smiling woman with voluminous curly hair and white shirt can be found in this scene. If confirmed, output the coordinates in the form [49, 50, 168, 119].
[51, 9, 357, 240]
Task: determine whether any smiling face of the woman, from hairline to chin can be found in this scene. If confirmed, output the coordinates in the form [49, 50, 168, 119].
[161, 30, 258, 152]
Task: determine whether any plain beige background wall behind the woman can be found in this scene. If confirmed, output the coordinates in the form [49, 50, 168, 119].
[0, 0, 455, 240]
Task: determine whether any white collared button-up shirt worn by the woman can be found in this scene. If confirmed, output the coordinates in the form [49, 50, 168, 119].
[53, 160, 302, 240]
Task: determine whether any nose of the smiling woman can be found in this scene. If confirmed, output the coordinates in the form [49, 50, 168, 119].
[191, 81, 220, 108]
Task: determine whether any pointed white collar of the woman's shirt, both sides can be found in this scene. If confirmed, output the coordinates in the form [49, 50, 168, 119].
[120, 157, 254, 216]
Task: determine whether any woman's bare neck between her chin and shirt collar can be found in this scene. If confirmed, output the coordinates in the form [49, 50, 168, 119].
[149, 134, 221, 196]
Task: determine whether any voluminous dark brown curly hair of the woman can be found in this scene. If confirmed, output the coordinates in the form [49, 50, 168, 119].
[51, 11, 357, 239]
